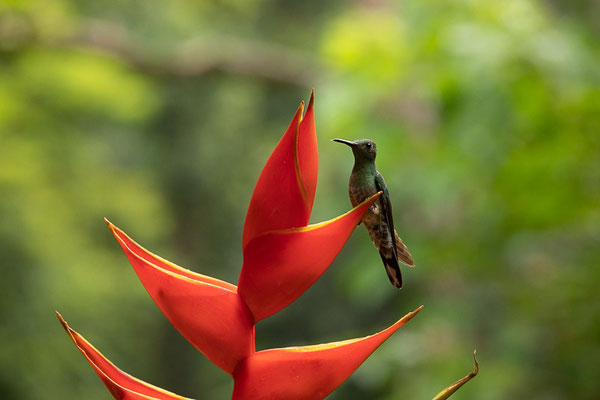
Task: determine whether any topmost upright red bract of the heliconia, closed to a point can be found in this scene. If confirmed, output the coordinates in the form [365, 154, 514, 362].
[242, 92, 318, 247]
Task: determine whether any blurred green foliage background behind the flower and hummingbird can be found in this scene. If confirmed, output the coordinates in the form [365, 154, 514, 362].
[0, 0, 600, 400]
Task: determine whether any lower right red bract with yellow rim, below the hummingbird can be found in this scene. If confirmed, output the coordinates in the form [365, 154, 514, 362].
[232, 306, 423, 400]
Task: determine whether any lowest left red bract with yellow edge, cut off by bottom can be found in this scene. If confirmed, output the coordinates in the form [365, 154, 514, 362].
[56, 312, 191, 400]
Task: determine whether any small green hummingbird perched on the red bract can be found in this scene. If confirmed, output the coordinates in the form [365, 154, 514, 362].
[333, 139, 415, 289]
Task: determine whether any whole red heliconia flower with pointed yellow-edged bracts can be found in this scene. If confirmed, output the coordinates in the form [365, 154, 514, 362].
[58, 91, 421, 400]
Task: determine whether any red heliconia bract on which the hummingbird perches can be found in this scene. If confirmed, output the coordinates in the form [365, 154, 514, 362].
[238, 193, 379, 321]
